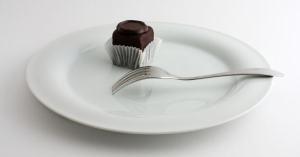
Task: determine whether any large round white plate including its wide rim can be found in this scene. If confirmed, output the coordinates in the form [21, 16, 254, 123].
[27, 23, 271, 134]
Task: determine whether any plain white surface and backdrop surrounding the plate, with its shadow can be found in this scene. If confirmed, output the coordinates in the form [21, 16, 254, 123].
[0, 0, 300, 157]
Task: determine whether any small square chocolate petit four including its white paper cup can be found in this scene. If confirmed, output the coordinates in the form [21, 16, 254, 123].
[105, 20, 161, 69]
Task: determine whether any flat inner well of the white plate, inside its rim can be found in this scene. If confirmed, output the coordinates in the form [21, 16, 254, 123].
[68, 40, 235, 117]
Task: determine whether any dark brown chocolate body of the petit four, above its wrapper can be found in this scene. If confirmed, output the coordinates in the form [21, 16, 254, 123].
[112, 20, 154, 50]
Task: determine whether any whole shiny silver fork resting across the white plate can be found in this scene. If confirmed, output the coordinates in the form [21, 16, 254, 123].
[112, 66, 283, 94]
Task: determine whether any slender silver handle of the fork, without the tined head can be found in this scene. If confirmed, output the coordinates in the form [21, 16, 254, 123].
[172, 68, 283, 80]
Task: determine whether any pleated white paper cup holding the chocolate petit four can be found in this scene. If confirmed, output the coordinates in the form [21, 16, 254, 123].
[105, 38, 161, 69]
